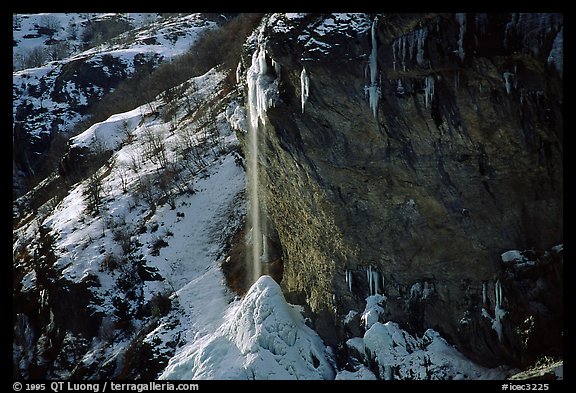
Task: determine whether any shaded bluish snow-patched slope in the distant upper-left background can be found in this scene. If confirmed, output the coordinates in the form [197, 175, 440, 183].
[12, 14, 216, 196]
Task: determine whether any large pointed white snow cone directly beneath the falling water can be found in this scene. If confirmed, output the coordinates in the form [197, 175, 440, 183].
[160, 276, 335, 379]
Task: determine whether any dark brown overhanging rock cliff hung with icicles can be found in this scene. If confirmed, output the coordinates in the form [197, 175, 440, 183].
[244, 14, 563, 366]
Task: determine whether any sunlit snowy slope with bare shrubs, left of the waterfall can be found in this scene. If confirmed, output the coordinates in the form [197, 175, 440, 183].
[14, 62, 245, 378]
